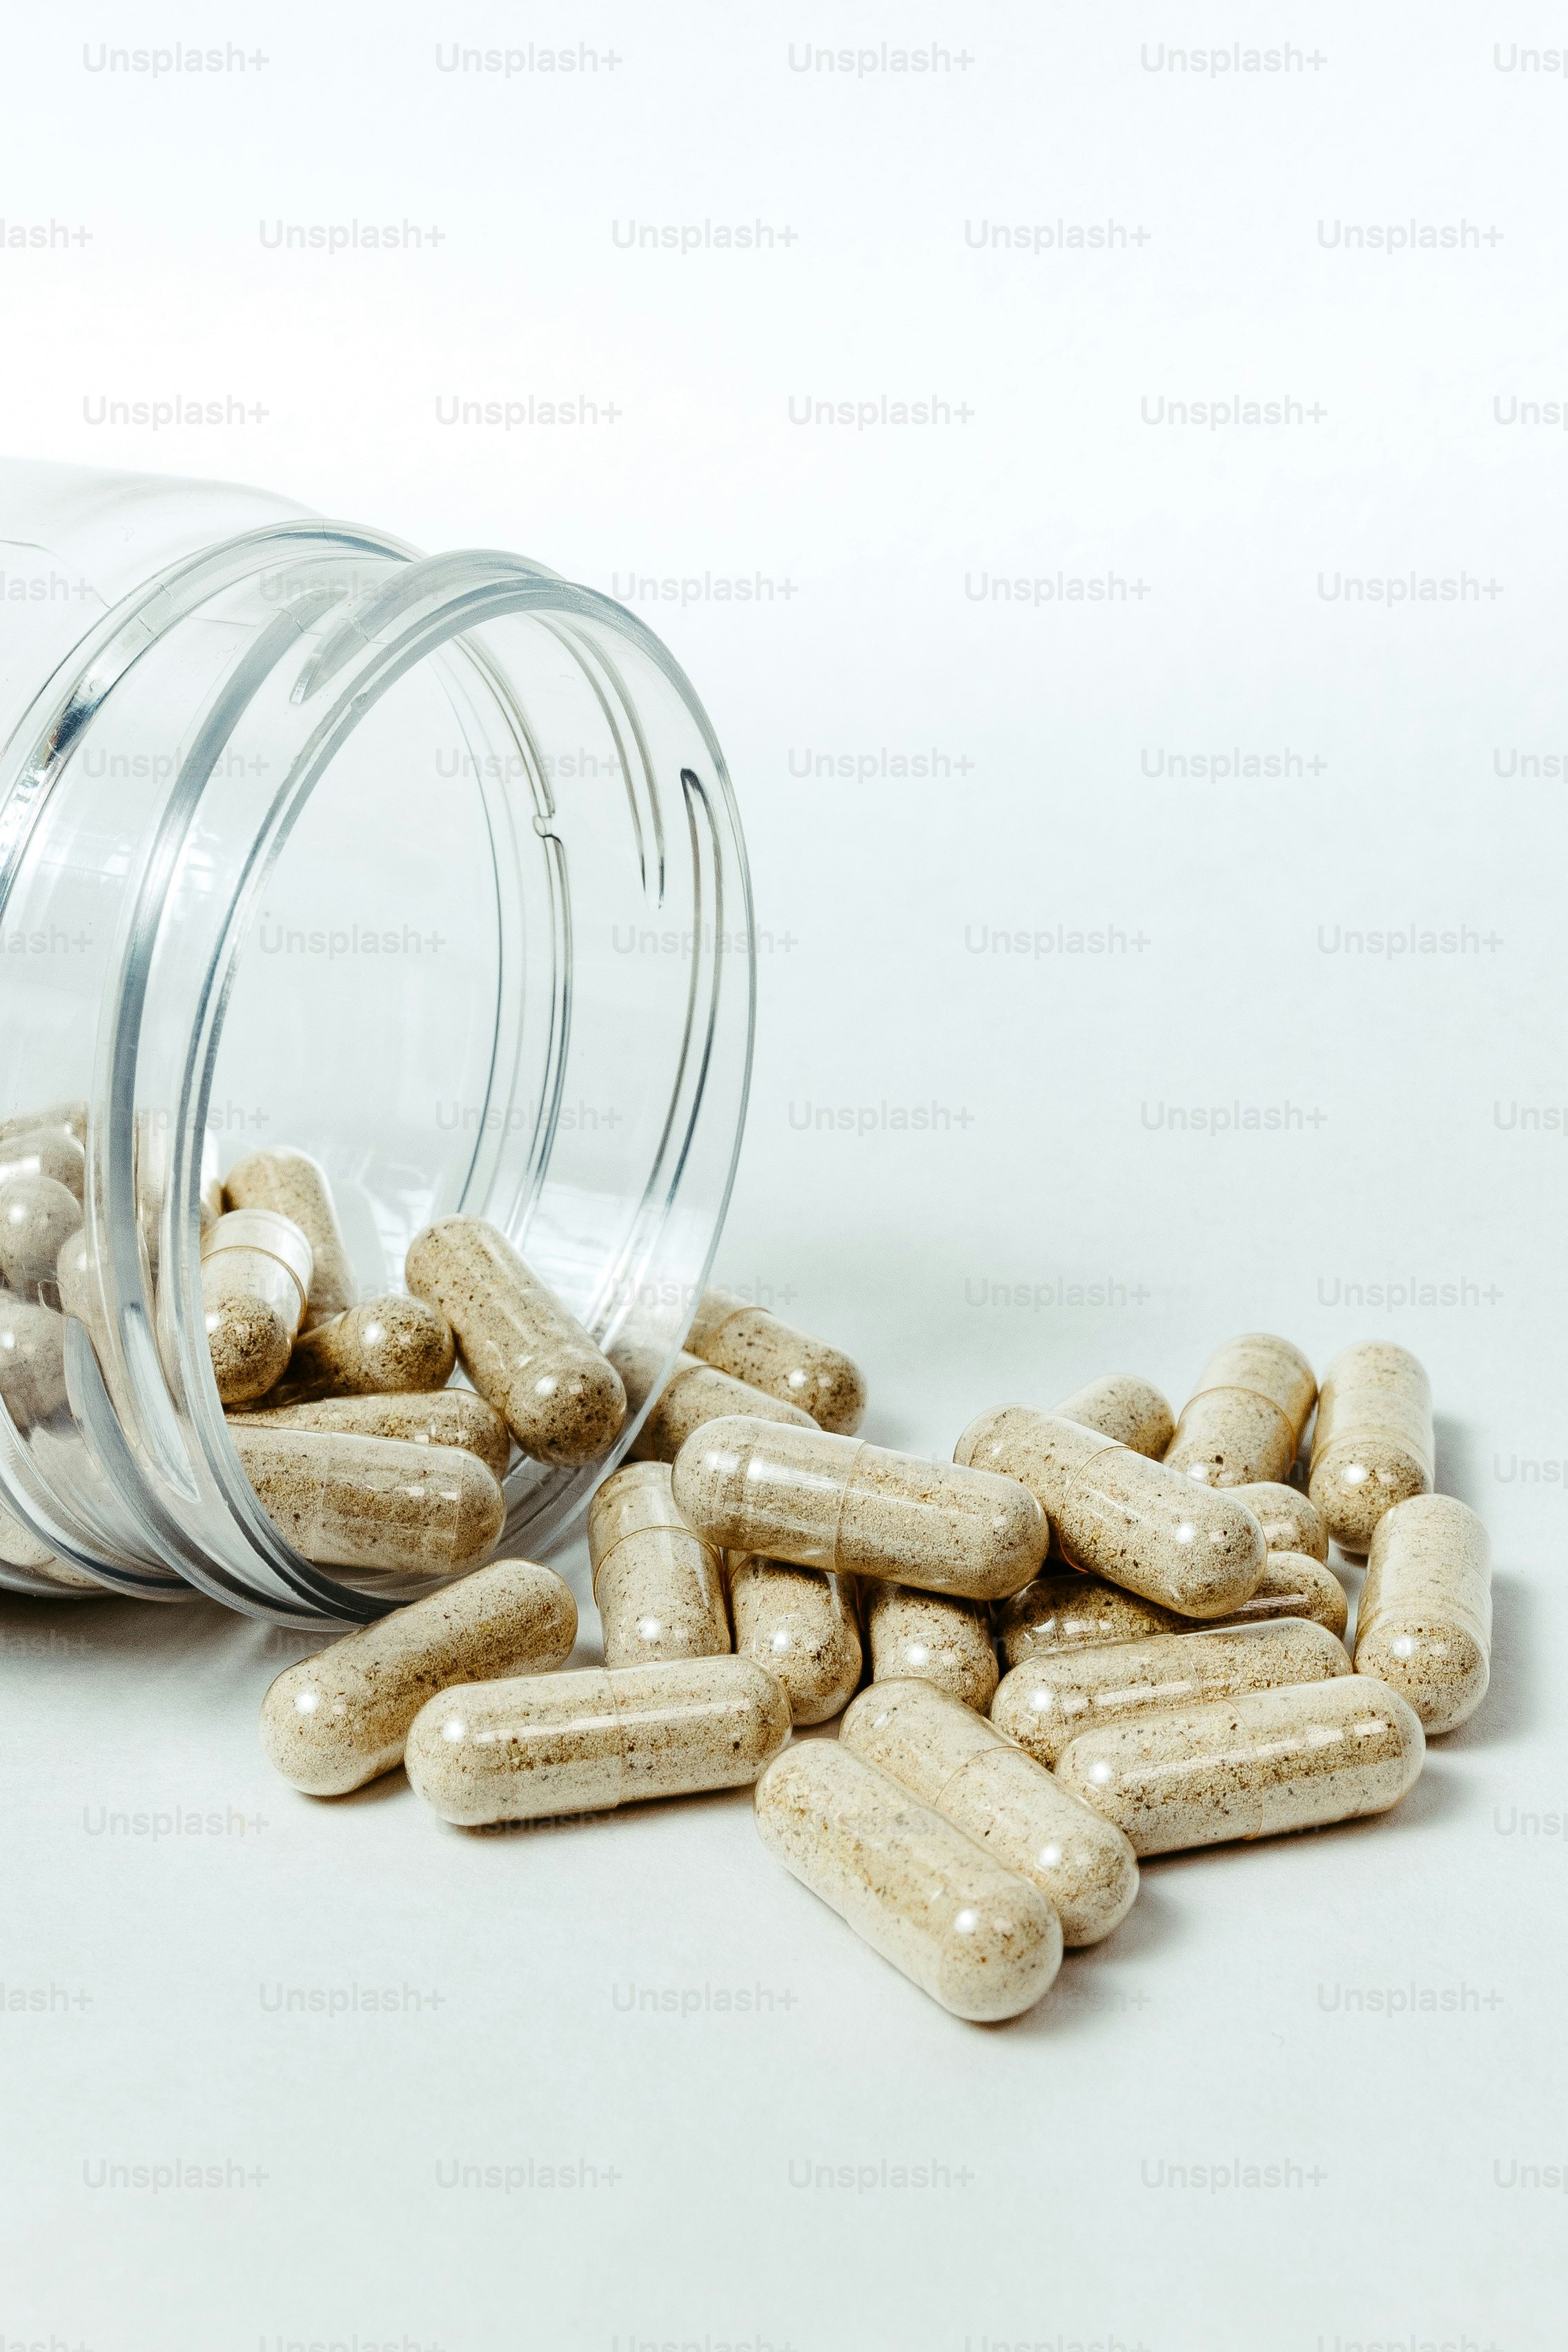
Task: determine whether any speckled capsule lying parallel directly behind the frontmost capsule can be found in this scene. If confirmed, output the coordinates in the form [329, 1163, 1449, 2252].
[839, 1682, 1138, 1945]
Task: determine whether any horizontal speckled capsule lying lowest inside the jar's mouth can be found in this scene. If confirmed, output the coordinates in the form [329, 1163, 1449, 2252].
[228, 1418, 505, 1576]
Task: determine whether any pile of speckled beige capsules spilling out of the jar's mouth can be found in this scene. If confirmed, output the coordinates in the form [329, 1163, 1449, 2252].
[196, 1153, 1491, 2020]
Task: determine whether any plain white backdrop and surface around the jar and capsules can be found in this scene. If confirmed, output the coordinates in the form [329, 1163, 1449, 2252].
[0, 0, 1568, 2352]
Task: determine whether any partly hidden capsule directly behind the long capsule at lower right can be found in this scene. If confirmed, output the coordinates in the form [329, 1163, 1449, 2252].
[992, 1618, 1349, 1764]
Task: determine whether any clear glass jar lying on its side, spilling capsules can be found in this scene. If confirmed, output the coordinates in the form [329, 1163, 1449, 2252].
[0, 463, 754, 1623]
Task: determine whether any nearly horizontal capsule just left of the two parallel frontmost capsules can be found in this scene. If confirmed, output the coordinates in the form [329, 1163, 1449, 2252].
[404, 1658, 790, 1830]
